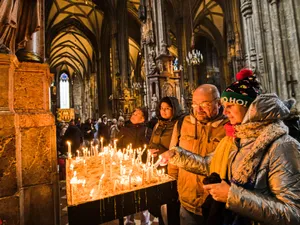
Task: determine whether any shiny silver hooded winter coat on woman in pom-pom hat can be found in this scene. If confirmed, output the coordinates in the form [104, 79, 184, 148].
[168, 94, 300, 225]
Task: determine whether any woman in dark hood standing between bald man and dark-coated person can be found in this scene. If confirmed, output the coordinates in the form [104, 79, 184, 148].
[148, 97, 185, 225]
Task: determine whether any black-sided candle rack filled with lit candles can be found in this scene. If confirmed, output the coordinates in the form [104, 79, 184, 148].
[66, 147, 177, 225]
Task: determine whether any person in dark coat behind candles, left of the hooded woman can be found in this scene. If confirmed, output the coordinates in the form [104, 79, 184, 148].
[118, 108, 152, 225]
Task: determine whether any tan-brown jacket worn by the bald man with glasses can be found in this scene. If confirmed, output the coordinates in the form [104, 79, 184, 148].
[168, 113, 228, 215]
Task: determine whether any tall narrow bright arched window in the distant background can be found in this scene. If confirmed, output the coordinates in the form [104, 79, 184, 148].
[59, 73, 70, 109]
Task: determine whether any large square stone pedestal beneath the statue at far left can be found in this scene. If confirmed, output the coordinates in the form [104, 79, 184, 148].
[0, 54, 59, 225]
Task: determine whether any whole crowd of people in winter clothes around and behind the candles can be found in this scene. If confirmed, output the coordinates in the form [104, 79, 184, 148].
[56, 69, 300, 225]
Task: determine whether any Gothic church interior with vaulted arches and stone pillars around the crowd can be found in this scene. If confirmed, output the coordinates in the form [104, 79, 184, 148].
[0, 0, 300, 225]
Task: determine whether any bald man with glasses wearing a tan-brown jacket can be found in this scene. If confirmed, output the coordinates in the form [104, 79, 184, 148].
[168, 84, 228, 225]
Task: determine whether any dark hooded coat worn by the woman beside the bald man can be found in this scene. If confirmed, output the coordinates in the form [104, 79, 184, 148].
[148, 97, 184, 155]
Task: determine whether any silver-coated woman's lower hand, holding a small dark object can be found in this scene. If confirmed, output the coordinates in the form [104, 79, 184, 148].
[203, 180, 230, 203]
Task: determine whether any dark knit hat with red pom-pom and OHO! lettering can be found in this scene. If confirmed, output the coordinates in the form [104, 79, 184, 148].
[221, 69, 260, 107]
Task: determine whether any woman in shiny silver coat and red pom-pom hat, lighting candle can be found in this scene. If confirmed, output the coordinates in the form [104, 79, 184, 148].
[163, 70, 300, 225]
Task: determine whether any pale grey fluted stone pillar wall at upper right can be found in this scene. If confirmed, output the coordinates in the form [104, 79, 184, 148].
[241, 0, 300, 109]
